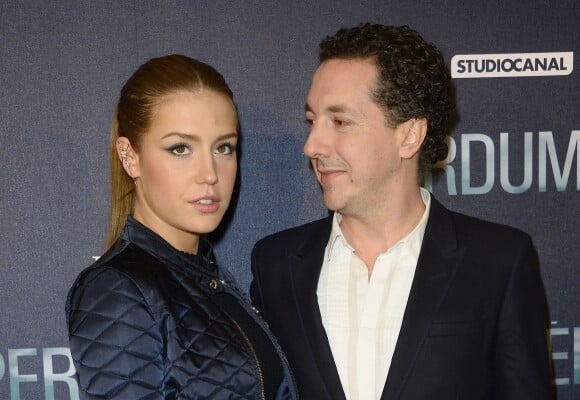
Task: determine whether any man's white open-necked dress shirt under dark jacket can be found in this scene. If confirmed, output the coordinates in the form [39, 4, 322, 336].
[317, 188, 431, 400]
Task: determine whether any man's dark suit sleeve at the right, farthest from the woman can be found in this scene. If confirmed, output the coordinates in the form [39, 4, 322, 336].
[494, 237, 552, 400]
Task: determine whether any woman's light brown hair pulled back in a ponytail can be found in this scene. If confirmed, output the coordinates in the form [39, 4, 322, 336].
[106, 54, 233, 248]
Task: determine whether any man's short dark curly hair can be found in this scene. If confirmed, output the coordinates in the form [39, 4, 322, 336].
[320, 23, 455, 177]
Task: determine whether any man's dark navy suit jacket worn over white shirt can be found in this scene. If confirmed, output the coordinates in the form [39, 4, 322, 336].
[250, 197, 552, 400]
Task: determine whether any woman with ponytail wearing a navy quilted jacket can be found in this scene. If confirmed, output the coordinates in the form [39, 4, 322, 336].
[67, 55, 296, 400]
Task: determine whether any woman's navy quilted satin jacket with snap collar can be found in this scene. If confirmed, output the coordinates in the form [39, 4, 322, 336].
[66, 216, 297, 400]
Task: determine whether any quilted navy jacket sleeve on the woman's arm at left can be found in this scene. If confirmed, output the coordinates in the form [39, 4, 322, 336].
[67, 268, 164, 400]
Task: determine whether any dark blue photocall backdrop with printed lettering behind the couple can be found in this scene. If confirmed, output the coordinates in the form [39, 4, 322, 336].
[0, 0, 580, 400]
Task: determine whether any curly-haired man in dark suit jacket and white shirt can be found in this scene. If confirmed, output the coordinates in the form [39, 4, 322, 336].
[251, 24, 551, 400]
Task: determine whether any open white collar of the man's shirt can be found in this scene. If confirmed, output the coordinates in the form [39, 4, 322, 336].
[326, 187, 431, 261]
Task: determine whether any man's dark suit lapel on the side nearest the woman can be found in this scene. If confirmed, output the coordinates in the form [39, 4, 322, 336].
[289, 218, 346, 400]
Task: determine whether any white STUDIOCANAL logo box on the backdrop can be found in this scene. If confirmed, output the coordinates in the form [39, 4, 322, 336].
[451, 51, 574, 78]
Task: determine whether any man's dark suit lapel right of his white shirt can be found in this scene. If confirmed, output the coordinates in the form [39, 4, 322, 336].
[381, 196, 463, 400]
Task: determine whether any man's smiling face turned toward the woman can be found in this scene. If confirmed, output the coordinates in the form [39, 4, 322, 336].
[304, 59, 404, 217]
